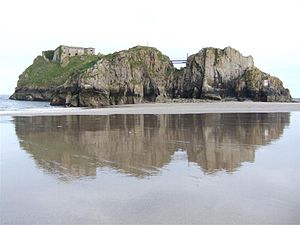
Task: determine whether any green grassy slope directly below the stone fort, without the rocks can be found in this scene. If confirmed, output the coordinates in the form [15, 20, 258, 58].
[18, 55, 101, 87]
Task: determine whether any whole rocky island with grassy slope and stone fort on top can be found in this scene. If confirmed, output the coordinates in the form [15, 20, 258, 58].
[10, 45, 292, 107]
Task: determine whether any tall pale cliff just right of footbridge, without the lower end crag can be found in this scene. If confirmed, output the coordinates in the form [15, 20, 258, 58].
[173, 47, 254, 100]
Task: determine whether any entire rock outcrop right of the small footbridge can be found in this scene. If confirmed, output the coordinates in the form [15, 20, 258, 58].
[172, 47, 291, 102]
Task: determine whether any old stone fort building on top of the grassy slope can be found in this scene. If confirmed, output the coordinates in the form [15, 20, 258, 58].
[42, 45, 95, 64]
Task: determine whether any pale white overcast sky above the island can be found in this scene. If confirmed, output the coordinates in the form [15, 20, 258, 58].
[0, 0, 300, 97]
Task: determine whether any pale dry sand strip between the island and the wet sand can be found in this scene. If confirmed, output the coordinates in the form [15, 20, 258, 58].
[0, 102, 300, 116]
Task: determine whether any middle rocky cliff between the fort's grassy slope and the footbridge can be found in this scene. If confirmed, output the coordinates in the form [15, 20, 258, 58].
[51, 46, 175, 107]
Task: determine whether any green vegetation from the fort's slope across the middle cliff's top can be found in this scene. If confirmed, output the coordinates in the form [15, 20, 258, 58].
[18, 46, 174, 87]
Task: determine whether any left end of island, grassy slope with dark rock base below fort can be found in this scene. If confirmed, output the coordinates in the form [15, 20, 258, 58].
[10, 55, 100, 101]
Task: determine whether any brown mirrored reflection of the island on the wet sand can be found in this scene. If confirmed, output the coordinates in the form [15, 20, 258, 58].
[14, 113, 290, 179]
